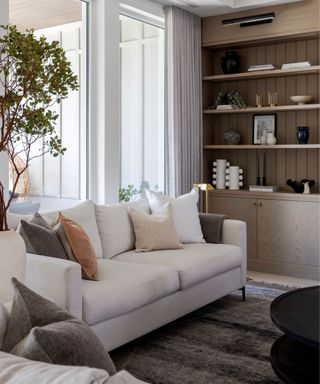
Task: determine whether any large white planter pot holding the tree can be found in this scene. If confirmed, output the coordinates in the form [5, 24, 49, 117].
[0, 231, 26, 303]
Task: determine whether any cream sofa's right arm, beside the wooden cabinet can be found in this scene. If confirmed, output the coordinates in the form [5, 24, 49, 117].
[222, 219, 247, 286]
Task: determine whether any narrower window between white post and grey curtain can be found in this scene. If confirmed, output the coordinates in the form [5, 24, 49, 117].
[120, 15, 164, 197]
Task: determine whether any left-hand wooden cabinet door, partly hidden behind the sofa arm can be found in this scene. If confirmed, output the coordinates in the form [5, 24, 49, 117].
[209, 196, 257, 259]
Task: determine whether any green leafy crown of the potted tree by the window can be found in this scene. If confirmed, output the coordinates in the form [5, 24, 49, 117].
[0, 25, 79, 156]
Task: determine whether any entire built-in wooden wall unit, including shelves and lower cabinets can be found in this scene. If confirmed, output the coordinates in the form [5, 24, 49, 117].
[202, 0, 320, 279]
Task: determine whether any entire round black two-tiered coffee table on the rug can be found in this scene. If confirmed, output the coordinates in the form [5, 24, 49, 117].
[270, 286, 320, 384]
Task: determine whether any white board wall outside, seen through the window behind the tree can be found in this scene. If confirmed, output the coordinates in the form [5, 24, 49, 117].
[29, 23, 81, 199]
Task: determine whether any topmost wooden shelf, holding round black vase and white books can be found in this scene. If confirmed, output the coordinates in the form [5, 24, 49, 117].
[203, 65, 320, 81]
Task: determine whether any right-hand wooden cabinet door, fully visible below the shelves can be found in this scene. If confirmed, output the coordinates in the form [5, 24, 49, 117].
[258, 200, 319, 267]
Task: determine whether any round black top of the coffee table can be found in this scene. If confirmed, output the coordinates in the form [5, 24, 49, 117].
[270, 286, 320, 348]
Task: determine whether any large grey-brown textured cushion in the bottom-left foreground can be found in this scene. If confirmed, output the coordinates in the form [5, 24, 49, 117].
[3, 279, 115, 374]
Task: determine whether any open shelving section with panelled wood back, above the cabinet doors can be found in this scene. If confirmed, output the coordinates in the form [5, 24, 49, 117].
[202, 34, 320, 193]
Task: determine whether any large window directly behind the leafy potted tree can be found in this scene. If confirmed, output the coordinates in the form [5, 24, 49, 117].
[9, 0, 88, 209]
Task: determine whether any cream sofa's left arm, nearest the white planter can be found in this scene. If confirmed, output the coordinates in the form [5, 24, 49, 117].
[25, 253, 82, 319]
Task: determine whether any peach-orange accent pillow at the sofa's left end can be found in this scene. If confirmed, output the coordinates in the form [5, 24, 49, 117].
[58, 212, 98, 280]
